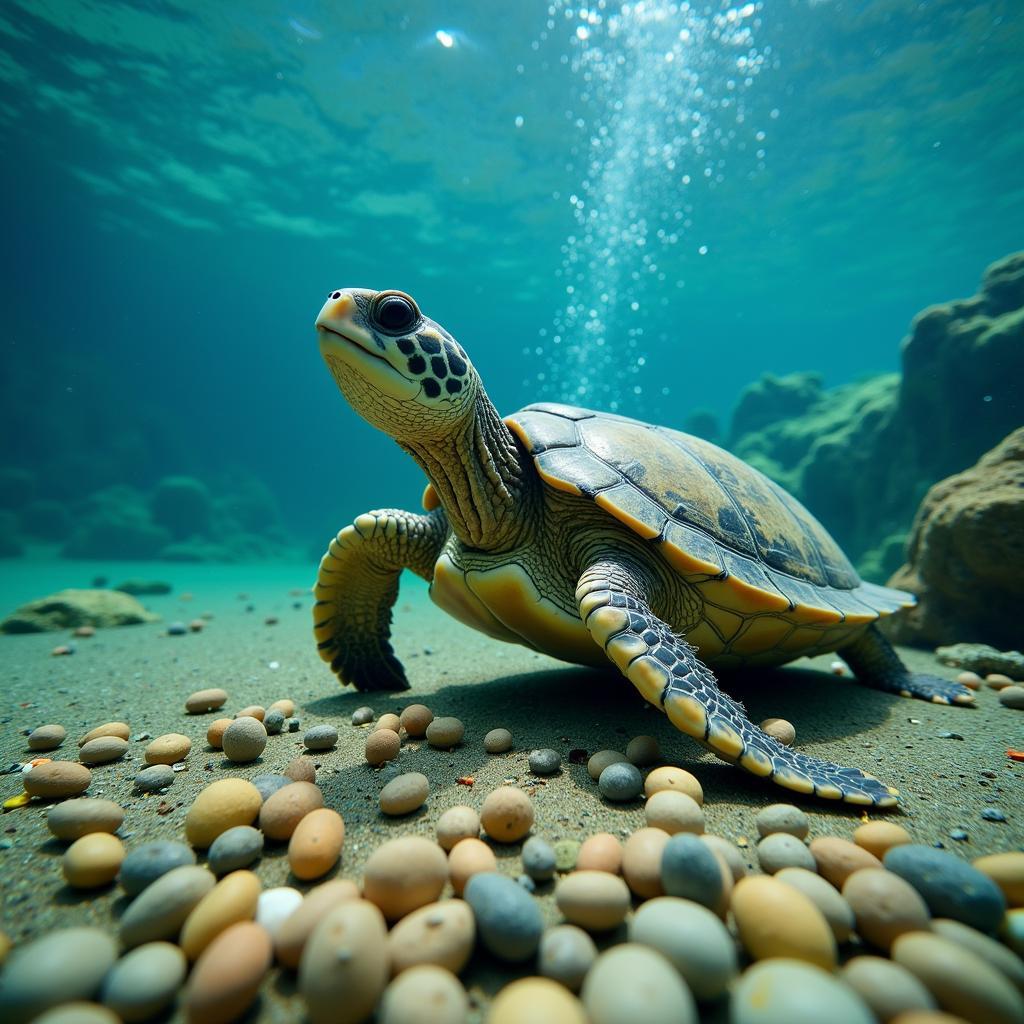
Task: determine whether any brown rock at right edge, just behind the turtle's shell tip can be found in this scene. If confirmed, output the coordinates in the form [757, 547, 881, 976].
[886, 427, 1024, 648]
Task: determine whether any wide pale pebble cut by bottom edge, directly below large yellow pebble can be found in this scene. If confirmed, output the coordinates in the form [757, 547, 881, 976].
[729, 958, 876, 1024]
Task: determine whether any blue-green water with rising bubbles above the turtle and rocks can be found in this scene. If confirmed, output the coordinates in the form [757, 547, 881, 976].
[0, 0, 1024, 550]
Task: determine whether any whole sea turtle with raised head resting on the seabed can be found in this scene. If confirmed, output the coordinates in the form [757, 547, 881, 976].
[313, 288, 974, 807]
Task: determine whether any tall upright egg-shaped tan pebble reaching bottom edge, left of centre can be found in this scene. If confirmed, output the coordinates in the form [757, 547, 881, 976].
[299, 901, 389, 1024]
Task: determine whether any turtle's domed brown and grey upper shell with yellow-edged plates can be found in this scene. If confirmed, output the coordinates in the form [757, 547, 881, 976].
[506, 402, 913, 623]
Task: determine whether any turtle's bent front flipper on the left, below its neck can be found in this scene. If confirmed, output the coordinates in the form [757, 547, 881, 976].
[313, 509, 447, 690]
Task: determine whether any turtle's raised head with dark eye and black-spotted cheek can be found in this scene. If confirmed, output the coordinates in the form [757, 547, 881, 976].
[316, 288, 480, 440]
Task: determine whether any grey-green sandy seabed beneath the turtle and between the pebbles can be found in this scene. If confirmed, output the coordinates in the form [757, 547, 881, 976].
[0, 560, 1024, 1021]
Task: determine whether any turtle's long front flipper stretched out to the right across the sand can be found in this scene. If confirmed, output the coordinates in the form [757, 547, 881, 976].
[575, 556, 896, 807]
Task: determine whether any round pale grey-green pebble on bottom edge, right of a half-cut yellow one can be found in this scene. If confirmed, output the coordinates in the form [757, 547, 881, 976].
[581, 942, 697, 1024]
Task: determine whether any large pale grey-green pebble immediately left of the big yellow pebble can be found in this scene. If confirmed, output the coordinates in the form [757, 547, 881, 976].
[629, 896, 738, 1001]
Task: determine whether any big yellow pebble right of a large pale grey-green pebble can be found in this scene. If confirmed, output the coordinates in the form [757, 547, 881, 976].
[732, 876, 836, 971]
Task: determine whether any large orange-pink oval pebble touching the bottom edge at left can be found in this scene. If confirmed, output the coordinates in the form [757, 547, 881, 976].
[182, 921, 273, 1024]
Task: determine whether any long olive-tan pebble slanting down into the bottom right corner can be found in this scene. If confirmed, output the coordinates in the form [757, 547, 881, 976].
[892, 932, 1024, 1024]
